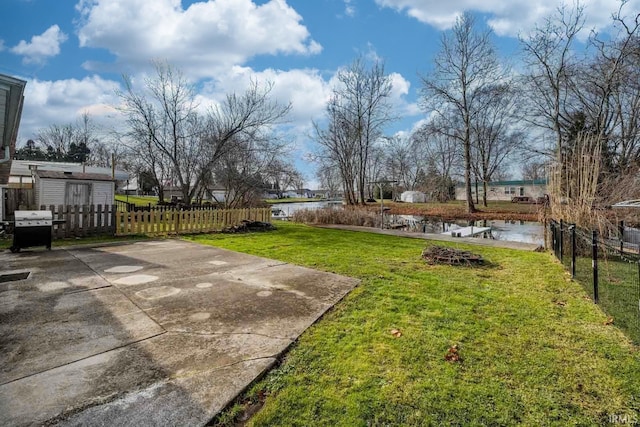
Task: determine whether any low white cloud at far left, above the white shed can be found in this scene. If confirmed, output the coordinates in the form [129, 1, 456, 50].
[20, 76, 119, 140]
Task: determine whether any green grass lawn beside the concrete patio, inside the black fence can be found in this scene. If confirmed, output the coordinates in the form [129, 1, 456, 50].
[190, 223, 640, 426]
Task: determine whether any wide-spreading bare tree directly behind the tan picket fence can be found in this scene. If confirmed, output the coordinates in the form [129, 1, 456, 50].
[120, 63, 290, 203]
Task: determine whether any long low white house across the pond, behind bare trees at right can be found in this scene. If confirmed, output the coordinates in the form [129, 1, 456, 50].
[456, 179, 547, 201]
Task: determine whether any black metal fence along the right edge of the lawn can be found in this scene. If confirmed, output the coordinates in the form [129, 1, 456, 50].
[549, 221, 640, 344]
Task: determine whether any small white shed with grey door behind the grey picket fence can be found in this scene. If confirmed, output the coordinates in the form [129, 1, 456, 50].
[34, 170, 115, 206]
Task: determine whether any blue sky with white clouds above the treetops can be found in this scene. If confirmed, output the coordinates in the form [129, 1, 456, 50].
[0, 0, 640, 183]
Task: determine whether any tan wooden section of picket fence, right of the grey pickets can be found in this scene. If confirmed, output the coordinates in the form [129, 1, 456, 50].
[115, 208, 271, 236]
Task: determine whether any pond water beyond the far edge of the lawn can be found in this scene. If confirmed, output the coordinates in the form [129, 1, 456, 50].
[272, 201, 544, 245]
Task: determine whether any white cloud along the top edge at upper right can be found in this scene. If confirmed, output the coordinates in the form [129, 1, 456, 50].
[375, 0, 640, 36]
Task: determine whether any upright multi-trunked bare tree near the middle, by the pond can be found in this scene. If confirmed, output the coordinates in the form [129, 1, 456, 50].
[315, 58, 393, 204]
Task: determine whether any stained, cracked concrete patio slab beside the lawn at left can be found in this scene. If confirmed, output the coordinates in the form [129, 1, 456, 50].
[0, 240, 357, 426]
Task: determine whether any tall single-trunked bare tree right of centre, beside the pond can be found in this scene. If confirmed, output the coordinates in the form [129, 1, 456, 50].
[422, 13, 504, 213]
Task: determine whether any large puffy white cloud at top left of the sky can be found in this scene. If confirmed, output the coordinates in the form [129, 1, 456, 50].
[77, 0, 322, 77]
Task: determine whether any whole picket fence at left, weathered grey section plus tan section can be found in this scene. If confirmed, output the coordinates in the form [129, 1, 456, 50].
[40, 205, 271, 239]
